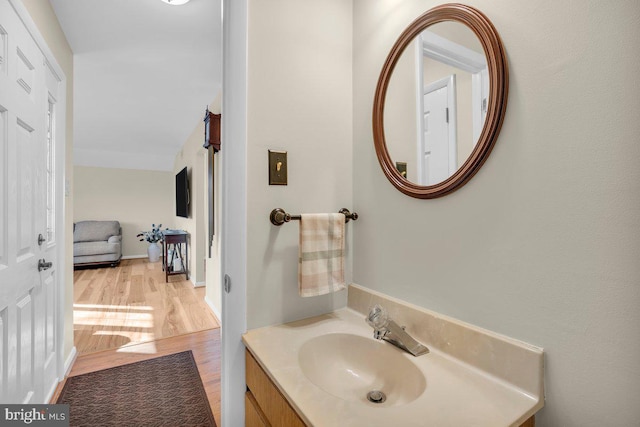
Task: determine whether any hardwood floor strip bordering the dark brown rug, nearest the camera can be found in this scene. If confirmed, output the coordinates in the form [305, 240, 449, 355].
[51, 328, 222, 426]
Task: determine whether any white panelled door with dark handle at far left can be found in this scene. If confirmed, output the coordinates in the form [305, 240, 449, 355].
[0, 0, 58, 403]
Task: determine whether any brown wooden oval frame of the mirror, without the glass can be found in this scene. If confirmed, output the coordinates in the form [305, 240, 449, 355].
[373, 3, 509, 199]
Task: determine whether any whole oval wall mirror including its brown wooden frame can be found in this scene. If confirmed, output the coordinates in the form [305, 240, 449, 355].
[373, 4, 508, 199]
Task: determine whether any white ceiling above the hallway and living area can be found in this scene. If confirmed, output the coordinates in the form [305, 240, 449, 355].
[50, 0, 222, 170]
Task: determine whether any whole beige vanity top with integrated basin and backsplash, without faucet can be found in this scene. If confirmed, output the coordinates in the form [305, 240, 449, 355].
[242, 308, 544, 427]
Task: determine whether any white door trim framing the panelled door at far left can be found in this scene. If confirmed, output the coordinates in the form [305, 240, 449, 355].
[9, 0, 68, 403]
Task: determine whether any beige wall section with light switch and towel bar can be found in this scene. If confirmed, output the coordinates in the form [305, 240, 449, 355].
[245, 0, 358, 328]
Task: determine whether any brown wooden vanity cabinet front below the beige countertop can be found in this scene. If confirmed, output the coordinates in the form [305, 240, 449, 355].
[245, 350, 305, 427]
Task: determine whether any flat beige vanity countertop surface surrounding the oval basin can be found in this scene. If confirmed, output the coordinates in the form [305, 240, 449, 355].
[243, 302, 544, 427]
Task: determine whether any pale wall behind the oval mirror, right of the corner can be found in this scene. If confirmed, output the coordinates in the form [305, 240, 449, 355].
[353, 0, 640, 427]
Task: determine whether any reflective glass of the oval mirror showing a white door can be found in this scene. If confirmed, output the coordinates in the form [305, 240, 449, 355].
[384, 21, 489, 186]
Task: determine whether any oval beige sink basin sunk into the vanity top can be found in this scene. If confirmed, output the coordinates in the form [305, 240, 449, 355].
[298, 333, 427, 406]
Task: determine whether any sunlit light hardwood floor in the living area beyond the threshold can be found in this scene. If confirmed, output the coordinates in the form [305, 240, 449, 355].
[73, 259, 220, 354]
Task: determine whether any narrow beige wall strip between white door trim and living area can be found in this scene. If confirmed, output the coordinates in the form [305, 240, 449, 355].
[22, 0, 74, 368]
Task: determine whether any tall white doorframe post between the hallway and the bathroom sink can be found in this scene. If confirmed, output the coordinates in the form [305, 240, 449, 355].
[220, 0, 249, 427]
